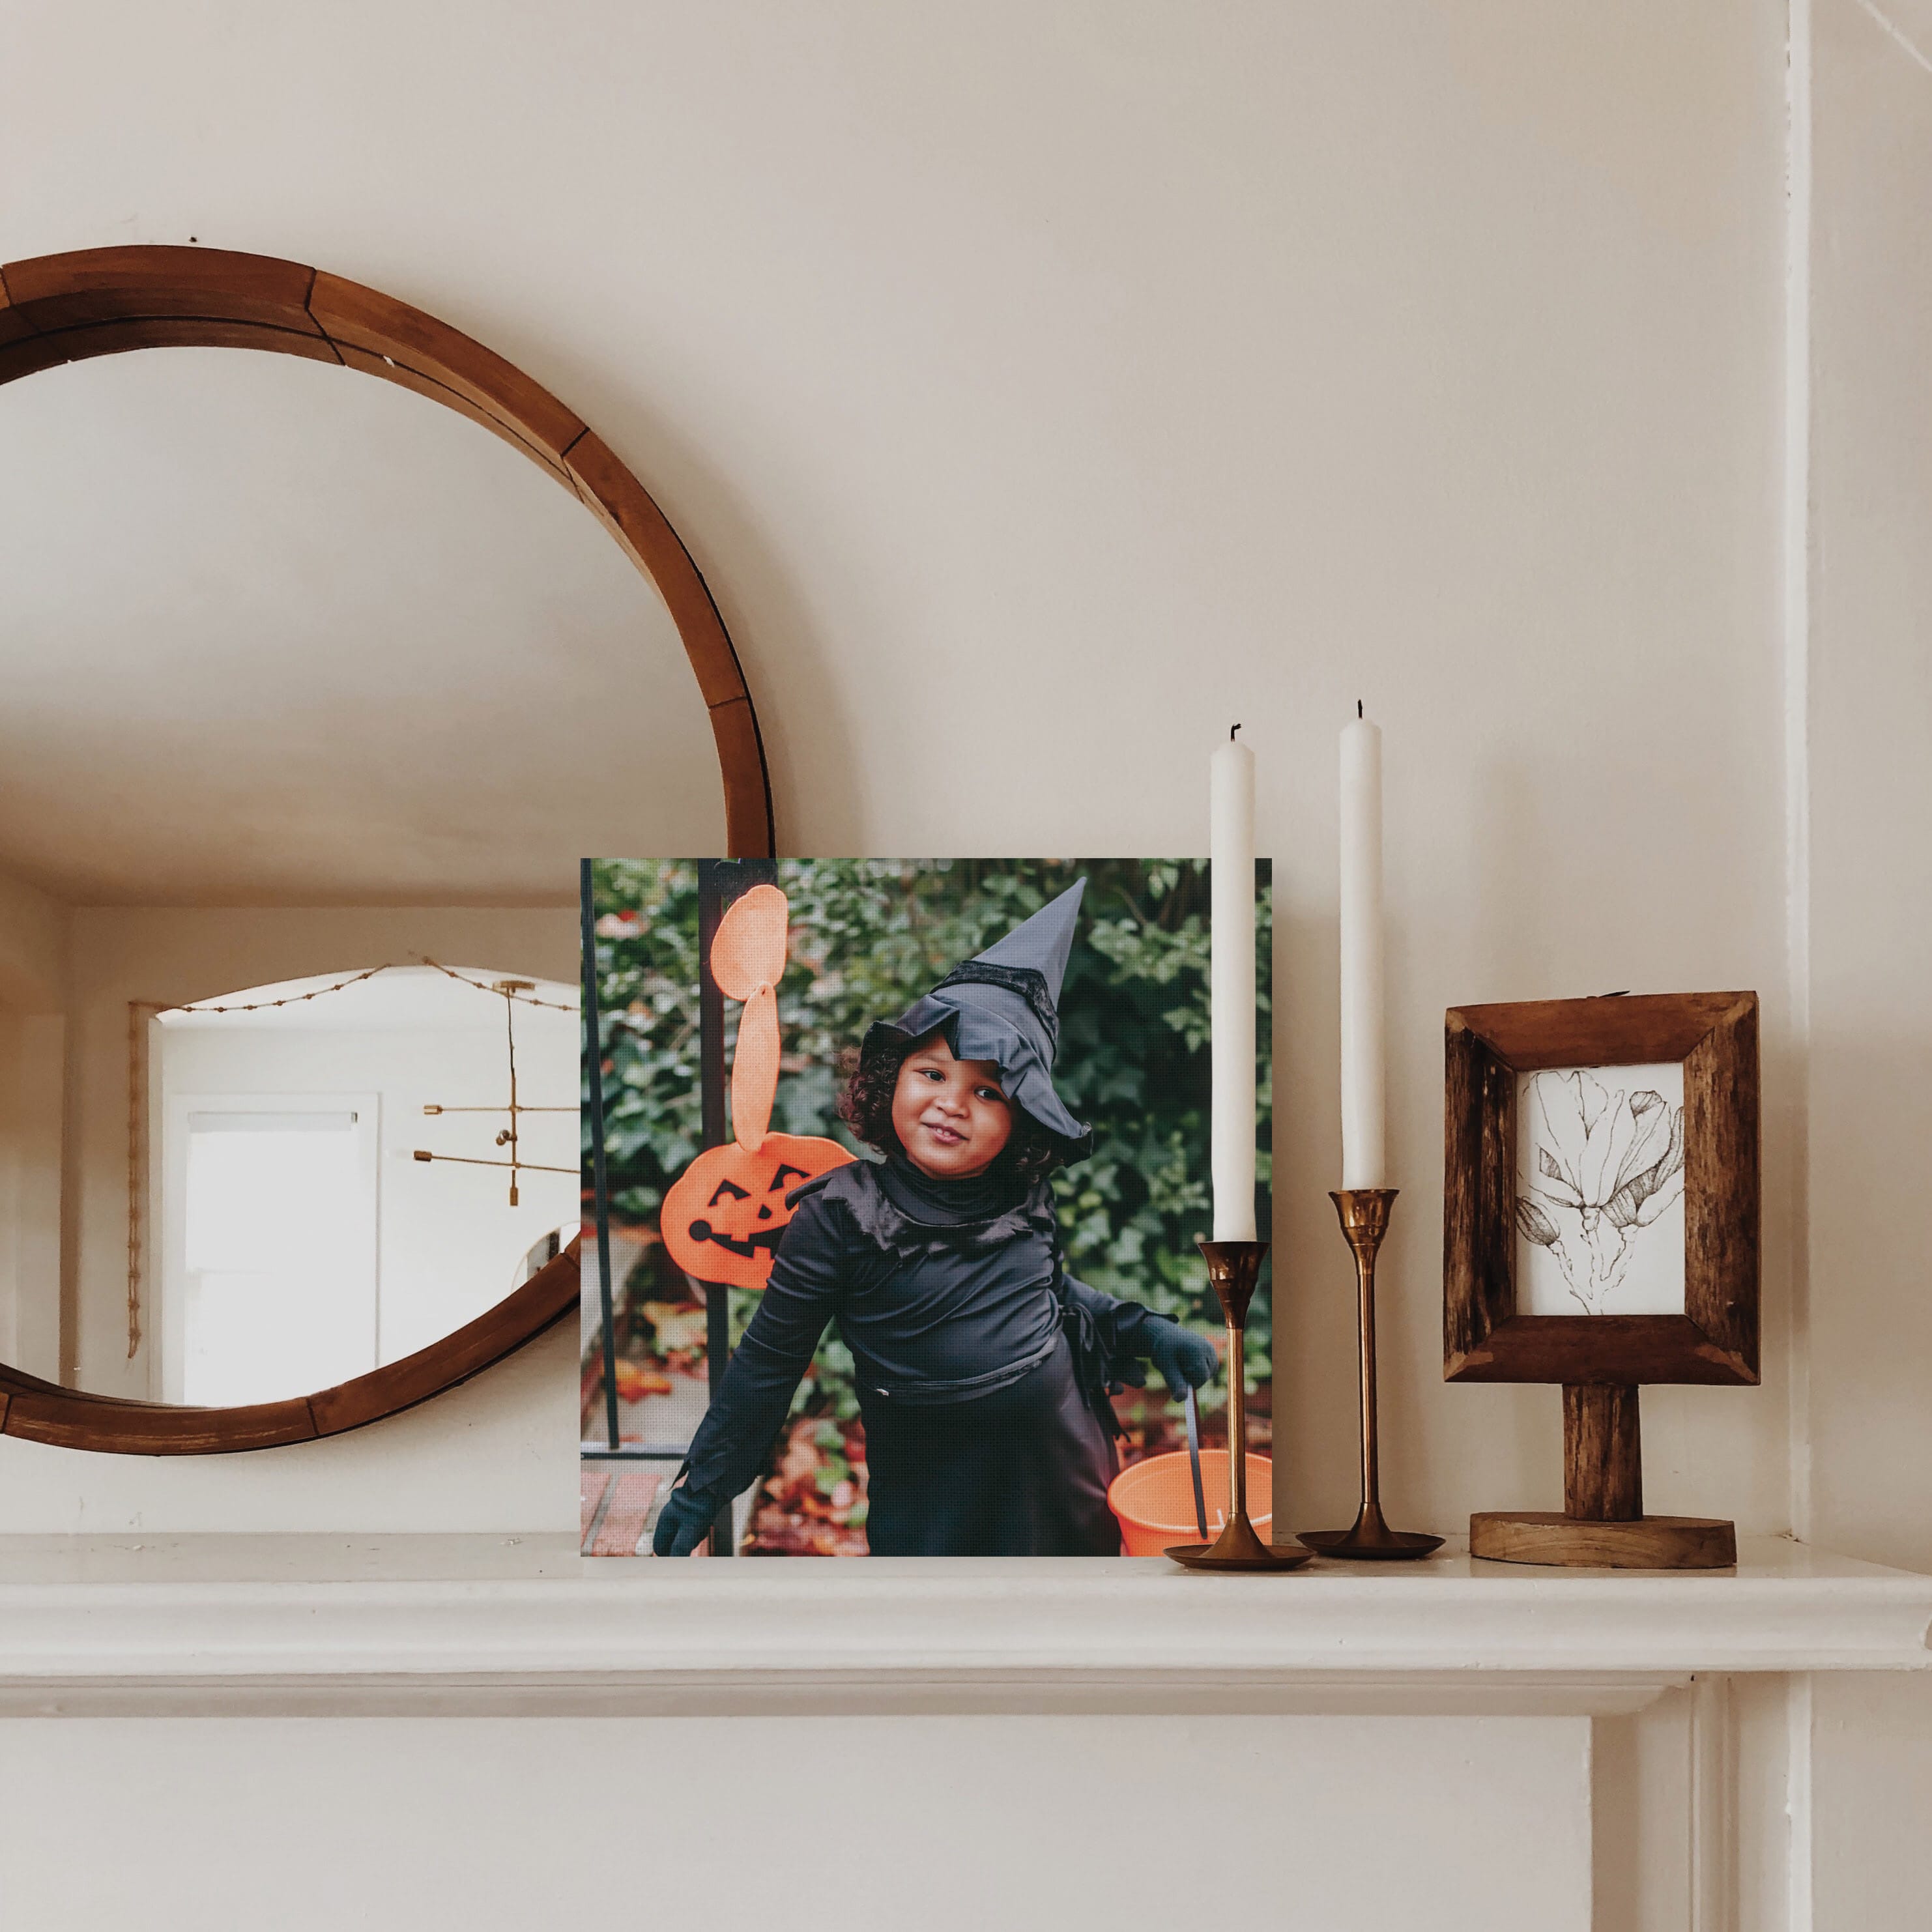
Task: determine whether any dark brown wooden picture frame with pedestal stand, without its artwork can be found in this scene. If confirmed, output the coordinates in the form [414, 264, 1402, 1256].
[1443, 993, 1762, 1567]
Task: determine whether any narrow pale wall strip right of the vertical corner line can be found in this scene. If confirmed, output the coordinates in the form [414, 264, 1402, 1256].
[1796, 0, 1932, 1909]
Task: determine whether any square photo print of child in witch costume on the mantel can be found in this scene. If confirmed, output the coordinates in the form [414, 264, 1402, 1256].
[583, 859, 1271, 1557]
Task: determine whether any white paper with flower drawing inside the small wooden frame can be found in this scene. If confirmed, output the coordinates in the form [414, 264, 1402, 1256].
[1517, 1061, 1684, 1316]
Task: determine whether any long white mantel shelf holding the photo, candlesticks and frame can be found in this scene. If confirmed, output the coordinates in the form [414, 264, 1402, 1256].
[0, 1536, 1932, 1714]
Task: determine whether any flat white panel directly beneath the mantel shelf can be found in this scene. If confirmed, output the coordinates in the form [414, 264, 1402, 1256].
[0, 1718, 1590, 1932]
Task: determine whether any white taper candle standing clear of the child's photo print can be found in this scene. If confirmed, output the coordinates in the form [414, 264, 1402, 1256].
[1341, 705, 1389, 1188]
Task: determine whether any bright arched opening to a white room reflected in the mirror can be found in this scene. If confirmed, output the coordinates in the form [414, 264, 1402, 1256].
[151, 966, 578, 1405]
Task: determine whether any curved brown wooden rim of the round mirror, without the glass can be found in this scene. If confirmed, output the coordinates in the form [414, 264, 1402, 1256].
[0, 246, 775, 1455]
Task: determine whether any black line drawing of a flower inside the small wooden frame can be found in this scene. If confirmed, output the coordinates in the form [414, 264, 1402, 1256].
[1517, 1071, 1684, 1316]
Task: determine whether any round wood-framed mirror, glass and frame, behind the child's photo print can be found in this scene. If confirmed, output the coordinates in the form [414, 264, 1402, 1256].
[0, 248, 773, 1455]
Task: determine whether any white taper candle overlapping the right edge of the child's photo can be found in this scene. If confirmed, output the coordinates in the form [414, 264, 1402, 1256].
[1207, 725, 1254, 1241]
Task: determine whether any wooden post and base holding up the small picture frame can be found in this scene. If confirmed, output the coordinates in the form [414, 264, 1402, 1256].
[1468, 1381, 1737, 1569]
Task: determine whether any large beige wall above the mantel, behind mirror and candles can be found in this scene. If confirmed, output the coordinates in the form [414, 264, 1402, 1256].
[0, 0, 1789, 1530]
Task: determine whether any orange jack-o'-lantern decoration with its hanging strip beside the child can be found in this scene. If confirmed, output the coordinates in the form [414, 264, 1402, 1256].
[659, 885, 852, 1289]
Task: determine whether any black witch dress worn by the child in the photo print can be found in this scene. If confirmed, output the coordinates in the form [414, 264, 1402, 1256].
[688, 1153, 1165, 1557]
